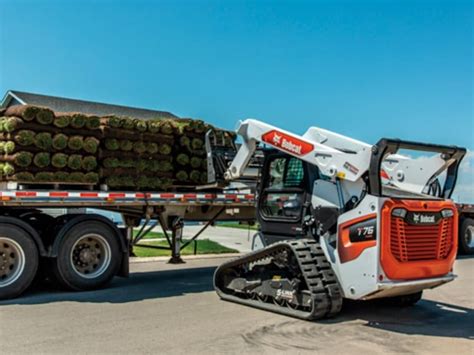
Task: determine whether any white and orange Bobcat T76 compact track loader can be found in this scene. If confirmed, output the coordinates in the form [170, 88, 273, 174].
[214, 119, 466, 320]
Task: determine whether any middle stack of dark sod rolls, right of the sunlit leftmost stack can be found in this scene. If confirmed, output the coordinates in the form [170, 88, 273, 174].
[99, 116, 174, 190]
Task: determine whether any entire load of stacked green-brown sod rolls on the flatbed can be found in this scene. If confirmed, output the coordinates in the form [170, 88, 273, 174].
[0, 105, 235, 191]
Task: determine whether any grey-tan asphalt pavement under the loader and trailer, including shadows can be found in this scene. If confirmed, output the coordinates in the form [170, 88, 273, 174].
[0, 258, 474, 354]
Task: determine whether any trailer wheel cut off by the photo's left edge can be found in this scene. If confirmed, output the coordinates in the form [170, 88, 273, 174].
[0, 224, 39, 299]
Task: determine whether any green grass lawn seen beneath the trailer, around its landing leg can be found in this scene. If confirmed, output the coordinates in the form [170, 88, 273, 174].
[133, 239, 238, 257]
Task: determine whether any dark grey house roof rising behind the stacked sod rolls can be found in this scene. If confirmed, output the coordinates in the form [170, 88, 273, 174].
[1, 90, 178, 119]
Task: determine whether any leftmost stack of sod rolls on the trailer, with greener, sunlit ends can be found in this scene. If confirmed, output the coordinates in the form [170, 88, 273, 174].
[0, 105, 100, 184]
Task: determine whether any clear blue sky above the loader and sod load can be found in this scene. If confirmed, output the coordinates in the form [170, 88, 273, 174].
[0, 0, 474, 201]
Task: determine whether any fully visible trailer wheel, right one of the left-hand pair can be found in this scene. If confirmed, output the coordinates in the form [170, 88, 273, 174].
[54, 221, 121, 291]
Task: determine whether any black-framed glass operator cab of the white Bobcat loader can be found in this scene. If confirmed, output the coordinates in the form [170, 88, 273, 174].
[257, 150, 319, 245]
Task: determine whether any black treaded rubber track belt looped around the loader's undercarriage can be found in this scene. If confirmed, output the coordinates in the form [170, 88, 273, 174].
[214, 239, 342, 320]
